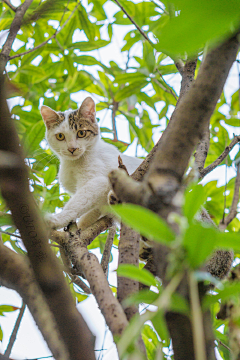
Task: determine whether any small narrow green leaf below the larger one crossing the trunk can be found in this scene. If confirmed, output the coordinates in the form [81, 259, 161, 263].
[117, 264, 157, 286]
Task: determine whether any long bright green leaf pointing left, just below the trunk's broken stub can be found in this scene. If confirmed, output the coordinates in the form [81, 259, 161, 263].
[110, 204, 175, 245]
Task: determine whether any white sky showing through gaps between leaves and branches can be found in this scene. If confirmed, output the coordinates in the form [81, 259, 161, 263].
[0, 0, 240, 360]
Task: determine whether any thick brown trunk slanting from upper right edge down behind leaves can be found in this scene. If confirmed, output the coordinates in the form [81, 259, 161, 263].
[110, 31, 239, 360]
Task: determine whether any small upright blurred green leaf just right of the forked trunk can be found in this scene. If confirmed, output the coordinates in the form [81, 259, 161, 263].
[183, 185, 206, 223]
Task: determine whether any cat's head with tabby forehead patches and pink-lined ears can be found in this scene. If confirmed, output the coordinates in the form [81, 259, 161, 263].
[41, 97, 99, 160]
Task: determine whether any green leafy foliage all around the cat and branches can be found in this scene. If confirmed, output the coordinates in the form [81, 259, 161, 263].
[0, 0, 240, 360]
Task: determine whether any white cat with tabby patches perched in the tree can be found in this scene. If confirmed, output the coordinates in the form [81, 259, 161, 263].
[41, 97, 141, 229]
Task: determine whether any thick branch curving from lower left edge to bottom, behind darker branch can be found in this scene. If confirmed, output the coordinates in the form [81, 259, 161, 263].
[0, 243, 69, 360]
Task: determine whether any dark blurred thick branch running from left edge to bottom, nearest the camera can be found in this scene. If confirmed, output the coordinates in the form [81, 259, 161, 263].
[0, 78, 95, 360]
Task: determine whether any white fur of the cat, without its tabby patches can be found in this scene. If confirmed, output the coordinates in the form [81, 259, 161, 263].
[43, 111, 141, 228]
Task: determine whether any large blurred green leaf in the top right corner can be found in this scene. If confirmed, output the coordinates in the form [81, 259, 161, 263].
[155, 0, 240, 55]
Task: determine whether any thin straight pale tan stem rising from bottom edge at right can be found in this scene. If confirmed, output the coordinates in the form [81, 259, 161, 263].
[189, 272, 207, 360]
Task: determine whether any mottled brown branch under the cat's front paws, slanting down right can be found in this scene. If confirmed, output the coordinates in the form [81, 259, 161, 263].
[52, 222, 128, 335]
